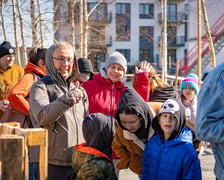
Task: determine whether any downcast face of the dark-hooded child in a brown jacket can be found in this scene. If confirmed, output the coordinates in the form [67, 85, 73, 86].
[119, 113, 141, 133]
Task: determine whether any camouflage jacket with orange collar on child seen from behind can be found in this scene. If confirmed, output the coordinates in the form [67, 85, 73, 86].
[72, 143, 117, 180]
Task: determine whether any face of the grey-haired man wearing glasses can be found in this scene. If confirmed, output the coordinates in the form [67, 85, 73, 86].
[52, 49, 74, 80]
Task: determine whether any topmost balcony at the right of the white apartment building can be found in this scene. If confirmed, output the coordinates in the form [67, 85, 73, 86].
[158, 12, 187, 24]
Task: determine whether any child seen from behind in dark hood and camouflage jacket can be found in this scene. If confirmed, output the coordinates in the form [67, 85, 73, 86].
[72, 113, 116, 180]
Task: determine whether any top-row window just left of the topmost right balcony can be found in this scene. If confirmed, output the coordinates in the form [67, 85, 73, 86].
[139, 3, 154, 19]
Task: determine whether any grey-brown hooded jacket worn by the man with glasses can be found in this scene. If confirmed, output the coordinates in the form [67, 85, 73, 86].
[29, 50, 88, 166]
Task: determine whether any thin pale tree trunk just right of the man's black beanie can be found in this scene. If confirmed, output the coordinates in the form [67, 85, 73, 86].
[12, 0, 21, 66]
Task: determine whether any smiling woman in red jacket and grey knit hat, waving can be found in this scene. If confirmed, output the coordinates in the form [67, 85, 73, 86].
[82, 52, 150, 117]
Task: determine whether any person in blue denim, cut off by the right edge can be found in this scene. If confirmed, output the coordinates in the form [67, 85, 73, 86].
[195, 63, 224, 179]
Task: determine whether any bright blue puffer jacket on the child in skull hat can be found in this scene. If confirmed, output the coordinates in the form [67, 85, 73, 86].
[141, 130, 202, 180]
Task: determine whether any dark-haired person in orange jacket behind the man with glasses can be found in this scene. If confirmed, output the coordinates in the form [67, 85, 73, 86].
[8, 48, 47, 119]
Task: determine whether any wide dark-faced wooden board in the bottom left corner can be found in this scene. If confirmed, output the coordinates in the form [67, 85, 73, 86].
[0, 135, 25, 180]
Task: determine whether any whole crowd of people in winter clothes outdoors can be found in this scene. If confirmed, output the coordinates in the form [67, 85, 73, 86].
[0, 41, 221, 180]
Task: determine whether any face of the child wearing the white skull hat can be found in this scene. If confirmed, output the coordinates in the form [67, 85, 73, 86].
[159, 113, 177, 139]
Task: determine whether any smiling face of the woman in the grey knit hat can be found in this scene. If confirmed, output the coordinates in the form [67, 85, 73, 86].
[107, 64, 124, 83]
